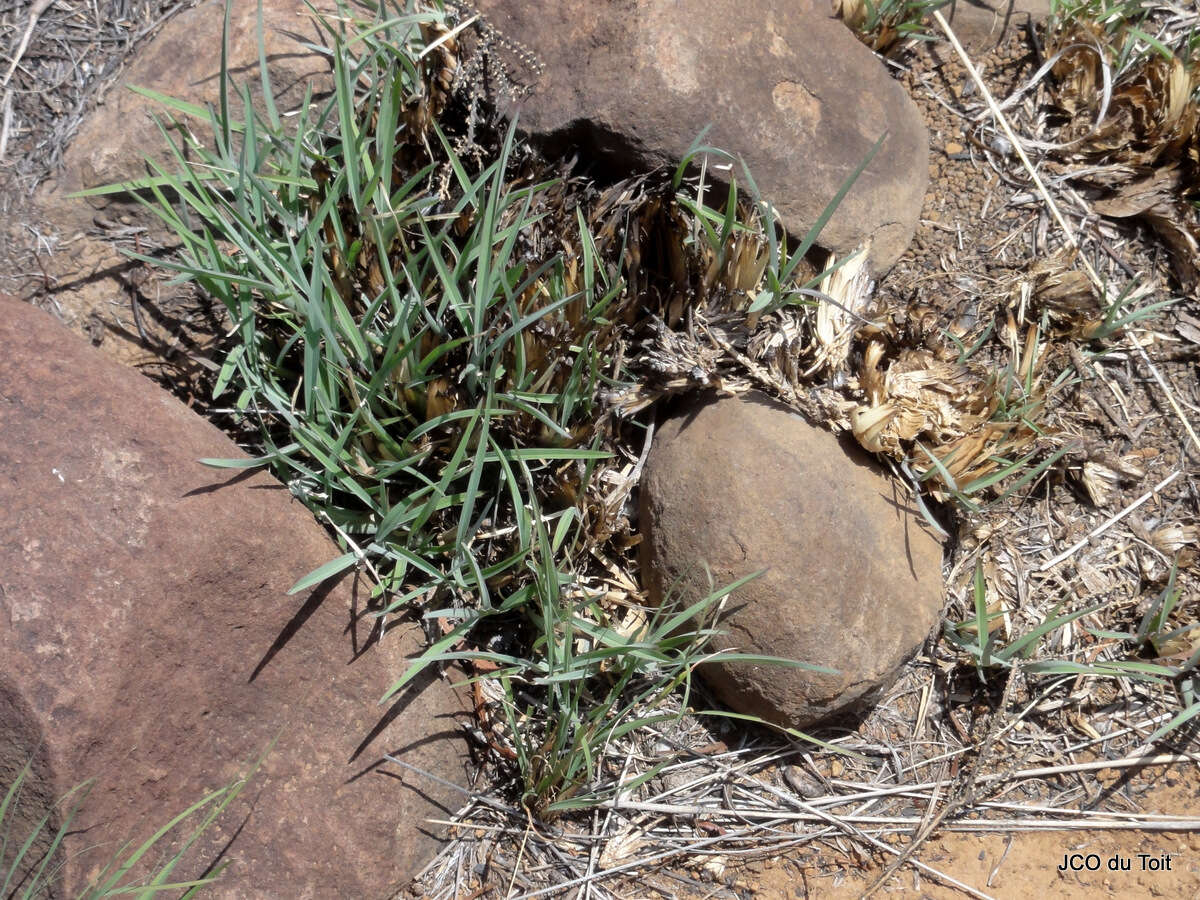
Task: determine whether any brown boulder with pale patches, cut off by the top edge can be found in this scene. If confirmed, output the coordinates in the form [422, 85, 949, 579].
[476, 0, 929, 270]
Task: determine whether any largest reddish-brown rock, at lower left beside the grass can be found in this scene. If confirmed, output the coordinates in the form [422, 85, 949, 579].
[0, 298, 466, 898]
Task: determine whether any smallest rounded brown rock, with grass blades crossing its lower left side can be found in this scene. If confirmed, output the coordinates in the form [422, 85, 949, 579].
[641, 395, 942, 728]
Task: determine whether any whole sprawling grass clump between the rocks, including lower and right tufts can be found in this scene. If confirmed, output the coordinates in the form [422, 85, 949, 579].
[79, 2, 865, 817]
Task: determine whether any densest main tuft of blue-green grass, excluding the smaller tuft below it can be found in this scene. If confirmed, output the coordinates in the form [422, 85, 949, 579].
[117, 5, 628, 633]
